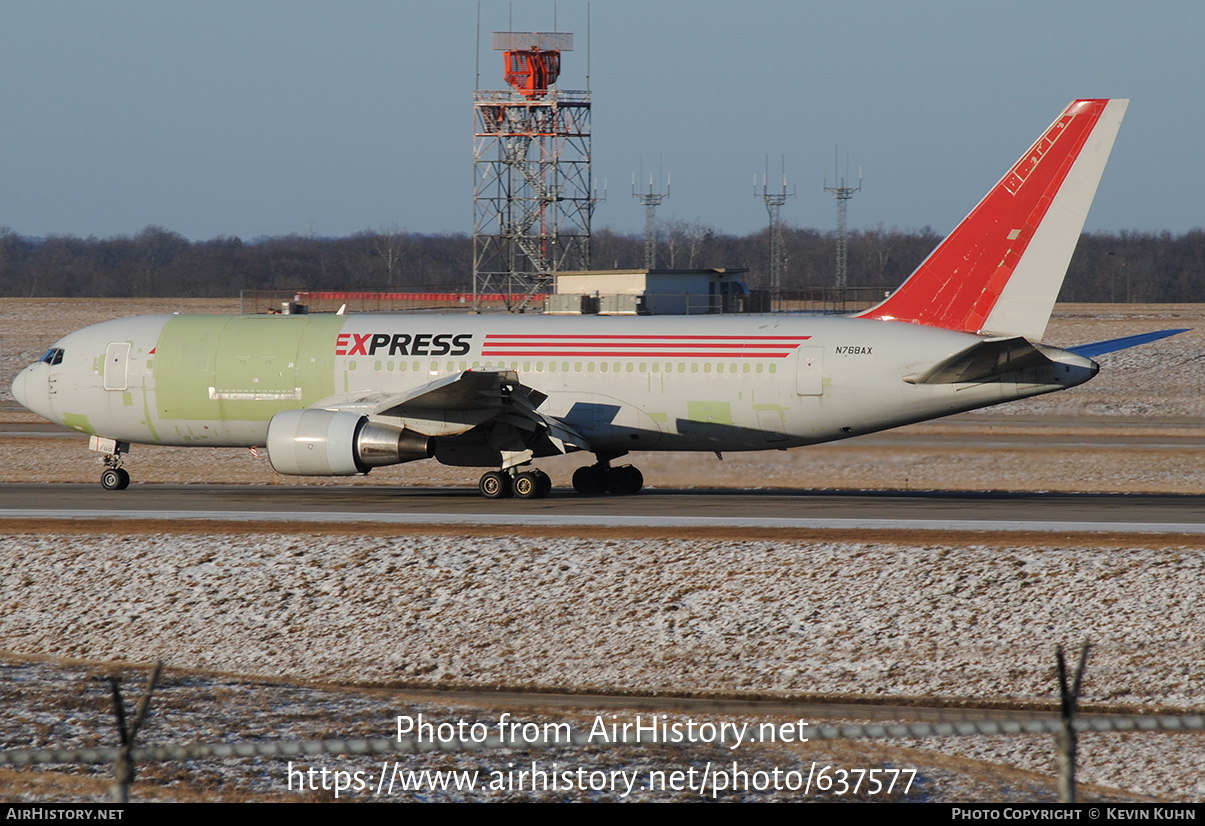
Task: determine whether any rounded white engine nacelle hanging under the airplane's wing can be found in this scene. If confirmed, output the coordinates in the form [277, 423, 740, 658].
[268, 410, 434, 476]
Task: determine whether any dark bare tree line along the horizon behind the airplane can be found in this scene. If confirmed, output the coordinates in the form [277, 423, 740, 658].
[0, 219, 1205, 303]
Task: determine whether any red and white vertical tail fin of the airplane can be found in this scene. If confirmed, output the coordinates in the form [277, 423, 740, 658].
[860, 100, 1129, 340]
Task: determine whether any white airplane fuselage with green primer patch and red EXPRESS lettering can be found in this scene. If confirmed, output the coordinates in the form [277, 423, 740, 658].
[13, 314, 1095, 453]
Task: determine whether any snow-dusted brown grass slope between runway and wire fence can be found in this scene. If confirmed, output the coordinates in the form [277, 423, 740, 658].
[0, 533, 1205, 799]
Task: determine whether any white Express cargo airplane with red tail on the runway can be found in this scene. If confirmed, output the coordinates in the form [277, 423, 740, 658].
[4, 99, 1182, 499]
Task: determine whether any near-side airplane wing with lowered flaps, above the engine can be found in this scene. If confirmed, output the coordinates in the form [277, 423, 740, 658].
[313, 369, 590, 455]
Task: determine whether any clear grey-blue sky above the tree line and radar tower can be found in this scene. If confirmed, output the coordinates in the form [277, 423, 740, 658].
[0, 0, 1205, 239]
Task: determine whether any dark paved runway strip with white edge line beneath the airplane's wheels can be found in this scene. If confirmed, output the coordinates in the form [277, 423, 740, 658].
[0, 484, 1205, 534]
